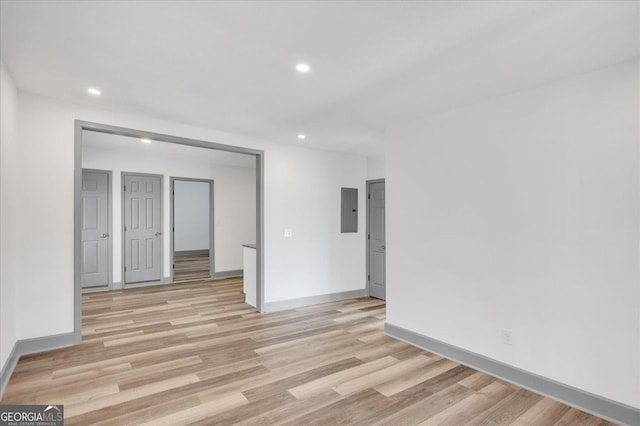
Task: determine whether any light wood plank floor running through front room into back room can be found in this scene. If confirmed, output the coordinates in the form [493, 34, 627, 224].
[1, 278, 609, 426]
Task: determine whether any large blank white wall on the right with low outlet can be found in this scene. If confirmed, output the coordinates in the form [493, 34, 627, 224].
[387, 61, 640, 407]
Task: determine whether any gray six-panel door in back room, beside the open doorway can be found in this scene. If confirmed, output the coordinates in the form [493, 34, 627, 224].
[123, 175, 162, 284]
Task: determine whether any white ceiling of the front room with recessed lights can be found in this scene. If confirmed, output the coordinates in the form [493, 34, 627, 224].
[0, 1, 640, 155]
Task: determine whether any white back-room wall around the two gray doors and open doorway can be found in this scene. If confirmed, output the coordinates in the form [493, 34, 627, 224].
[82, 141, 256, 283]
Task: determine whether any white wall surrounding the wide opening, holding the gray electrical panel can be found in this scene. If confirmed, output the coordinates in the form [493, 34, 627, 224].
[14, 92, 366, 338]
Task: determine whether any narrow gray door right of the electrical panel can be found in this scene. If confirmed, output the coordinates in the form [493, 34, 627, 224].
[367, 182, 387, 300]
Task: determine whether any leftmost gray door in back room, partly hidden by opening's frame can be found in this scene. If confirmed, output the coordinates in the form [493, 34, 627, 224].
[80, 171, 109, 288]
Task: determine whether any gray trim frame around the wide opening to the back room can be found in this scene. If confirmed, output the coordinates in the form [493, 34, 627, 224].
[73, 120, 264, 344]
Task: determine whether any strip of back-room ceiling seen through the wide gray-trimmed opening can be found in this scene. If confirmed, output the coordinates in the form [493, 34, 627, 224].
[82, 130, 256, 169]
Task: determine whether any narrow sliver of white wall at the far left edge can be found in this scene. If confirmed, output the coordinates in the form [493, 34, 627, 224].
[0, 62, 19, 370]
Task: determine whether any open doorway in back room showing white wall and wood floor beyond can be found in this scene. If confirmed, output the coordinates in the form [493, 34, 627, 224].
[170, 177, 216, 282]
